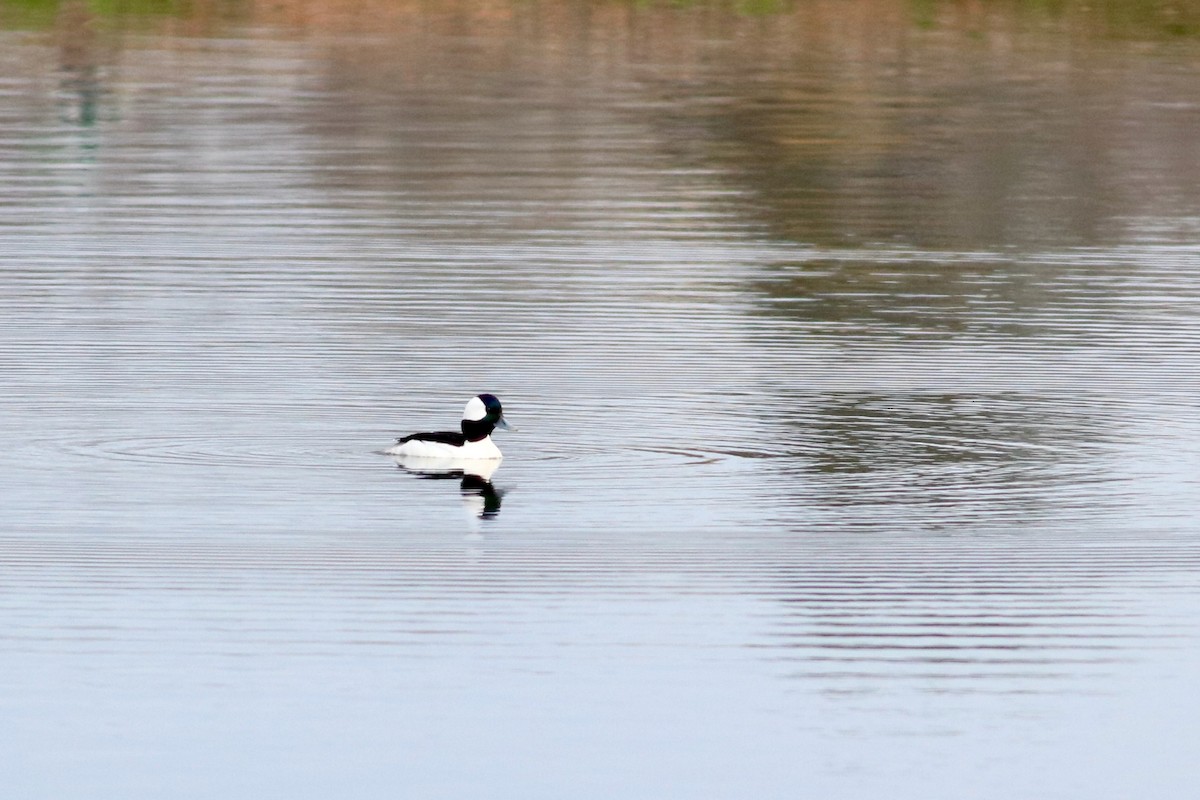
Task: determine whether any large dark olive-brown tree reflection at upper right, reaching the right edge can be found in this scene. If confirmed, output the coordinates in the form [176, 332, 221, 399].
[689, 10, 1200, 247]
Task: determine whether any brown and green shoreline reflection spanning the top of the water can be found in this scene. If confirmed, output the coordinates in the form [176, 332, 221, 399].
[14, 0, 1200, 247]
